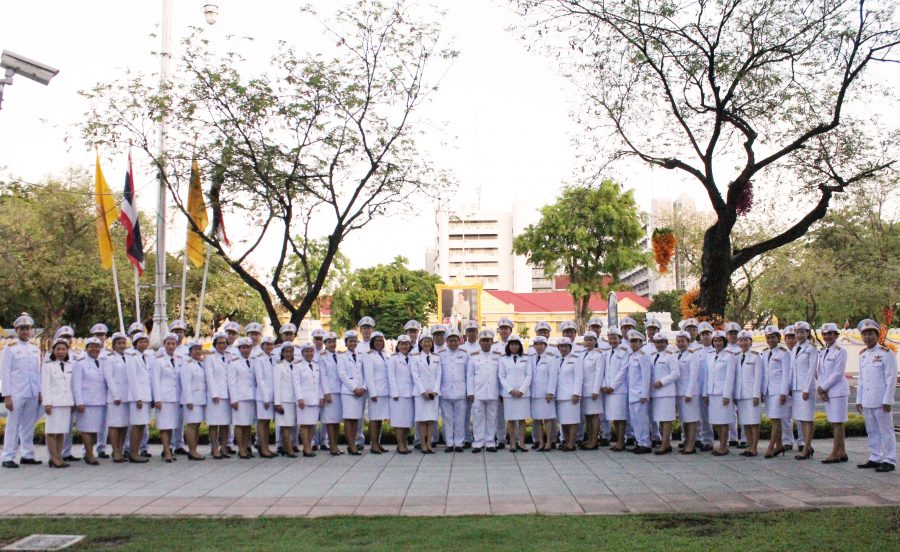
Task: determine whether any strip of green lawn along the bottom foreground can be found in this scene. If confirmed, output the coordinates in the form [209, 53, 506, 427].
[0, 508, 900, 551]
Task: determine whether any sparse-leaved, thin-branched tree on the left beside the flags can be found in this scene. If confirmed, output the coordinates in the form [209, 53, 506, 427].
[81, 2, 455, 327]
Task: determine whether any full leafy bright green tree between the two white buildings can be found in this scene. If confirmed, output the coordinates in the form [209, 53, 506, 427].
[513, 180, 649, 329]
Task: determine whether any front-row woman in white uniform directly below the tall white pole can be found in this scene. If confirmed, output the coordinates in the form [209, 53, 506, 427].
[153, 333, 181, 463]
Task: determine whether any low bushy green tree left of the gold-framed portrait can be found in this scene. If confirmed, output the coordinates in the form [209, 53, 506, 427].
[331, 256, 441, 338]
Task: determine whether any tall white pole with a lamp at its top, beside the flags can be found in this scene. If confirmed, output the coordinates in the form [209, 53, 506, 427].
[150, 0, 219, 348]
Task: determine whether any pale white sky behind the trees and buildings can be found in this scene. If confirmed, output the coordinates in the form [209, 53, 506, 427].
[0, 0, 888, 276]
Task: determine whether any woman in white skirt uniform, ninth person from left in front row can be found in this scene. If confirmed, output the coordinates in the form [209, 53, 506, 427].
[228, 337, 256, 460]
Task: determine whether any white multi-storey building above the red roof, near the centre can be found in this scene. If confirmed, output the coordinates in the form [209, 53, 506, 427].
[425, 201, 553, 293]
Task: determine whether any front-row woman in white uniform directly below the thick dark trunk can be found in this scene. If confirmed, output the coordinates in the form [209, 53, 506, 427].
[703, 330, 735, 456]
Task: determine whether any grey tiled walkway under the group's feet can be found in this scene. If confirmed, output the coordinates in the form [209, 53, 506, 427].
[0, 438, 900, 517]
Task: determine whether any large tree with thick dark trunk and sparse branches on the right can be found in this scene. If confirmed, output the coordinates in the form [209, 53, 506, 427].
[517, 0, 900, 317]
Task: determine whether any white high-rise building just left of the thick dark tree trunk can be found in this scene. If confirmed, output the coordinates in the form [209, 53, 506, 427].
[619, 193, 697, 298]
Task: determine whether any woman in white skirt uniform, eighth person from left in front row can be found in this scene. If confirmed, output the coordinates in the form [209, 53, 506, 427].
[204, 332, 231, 460]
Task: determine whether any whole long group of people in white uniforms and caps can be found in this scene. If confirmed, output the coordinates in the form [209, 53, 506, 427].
[0, 315, 897, 472]
